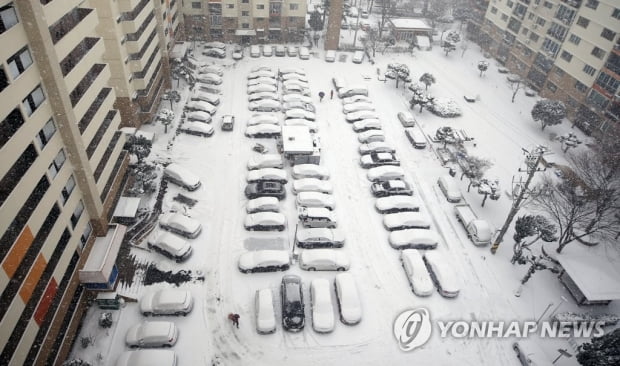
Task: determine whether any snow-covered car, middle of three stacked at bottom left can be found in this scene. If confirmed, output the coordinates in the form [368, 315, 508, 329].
[125, 321, 179, 348]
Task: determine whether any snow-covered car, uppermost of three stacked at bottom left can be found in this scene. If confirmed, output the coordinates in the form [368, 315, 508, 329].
[140, 289, 194, 316]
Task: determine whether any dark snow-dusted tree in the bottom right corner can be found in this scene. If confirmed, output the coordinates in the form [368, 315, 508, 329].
[577, 328, 620, 366]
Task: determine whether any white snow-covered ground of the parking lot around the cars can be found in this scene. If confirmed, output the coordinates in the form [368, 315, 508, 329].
[72, 37, 620, 366]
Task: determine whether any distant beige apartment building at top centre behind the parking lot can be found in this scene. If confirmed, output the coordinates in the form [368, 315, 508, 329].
[183, 0, 308, 44]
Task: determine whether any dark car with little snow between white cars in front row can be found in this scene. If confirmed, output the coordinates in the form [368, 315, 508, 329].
[280, 275, 305, 332]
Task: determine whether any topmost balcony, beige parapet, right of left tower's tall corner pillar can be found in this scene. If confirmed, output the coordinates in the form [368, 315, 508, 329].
[49, 8, 98, 60]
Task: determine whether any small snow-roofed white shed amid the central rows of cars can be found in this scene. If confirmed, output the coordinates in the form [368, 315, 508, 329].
[278, 126, 321, 165]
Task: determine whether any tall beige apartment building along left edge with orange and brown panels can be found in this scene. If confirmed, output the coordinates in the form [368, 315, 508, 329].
[0, 0, 183, 365]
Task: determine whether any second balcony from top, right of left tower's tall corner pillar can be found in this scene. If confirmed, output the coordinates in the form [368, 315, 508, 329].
[61, 38, 105, 90]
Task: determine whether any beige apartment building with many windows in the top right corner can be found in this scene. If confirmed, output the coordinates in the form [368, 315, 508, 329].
[479, 0, 620, 134]
